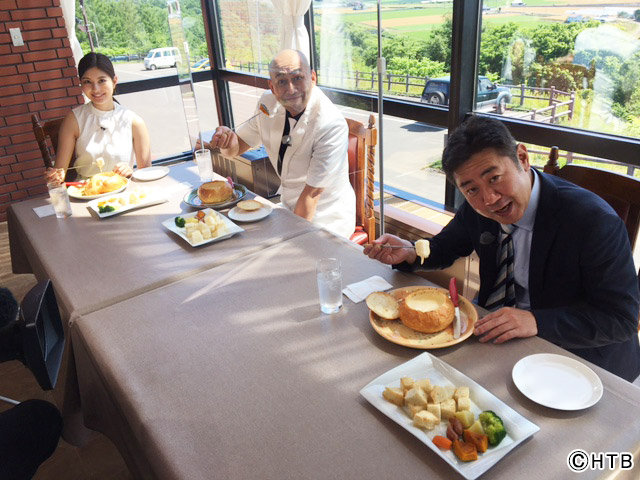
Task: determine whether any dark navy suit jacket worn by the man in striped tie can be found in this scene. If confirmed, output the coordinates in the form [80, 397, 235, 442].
[398, 173, 640, 381]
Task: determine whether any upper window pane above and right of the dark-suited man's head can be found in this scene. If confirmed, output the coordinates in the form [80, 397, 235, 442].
[478, 0, 640, 137]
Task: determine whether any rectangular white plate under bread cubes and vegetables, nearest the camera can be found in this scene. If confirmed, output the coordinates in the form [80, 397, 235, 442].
[360, 352, 540, 480]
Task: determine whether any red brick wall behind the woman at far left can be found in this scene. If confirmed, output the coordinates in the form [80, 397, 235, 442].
[0, 0, 84, 222]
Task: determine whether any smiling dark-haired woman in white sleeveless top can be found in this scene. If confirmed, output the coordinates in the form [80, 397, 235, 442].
[46, 53, 151, 182]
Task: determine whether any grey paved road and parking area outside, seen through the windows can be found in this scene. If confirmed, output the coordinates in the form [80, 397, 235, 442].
[115, 63, 446, 203]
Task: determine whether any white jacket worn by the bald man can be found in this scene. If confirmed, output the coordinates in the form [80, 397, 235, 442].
[236, 87, 356, 238]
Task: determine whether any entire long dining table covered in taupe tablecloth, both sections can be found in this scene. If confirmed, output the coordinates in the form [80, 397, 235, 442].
[8, 162, 640, 480]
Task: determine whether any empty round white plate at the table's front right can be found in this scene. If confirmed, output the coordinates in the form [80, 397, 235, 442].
[511, 353, 602, 410]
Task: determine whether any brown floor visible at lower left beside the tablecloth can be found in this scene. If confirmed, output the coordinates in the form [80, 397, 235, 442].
[0, 222, 133, 480]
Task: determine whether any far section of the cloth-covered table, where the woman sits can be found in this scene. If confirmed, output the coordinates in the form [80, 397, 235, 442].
[7, 161, 316, 320]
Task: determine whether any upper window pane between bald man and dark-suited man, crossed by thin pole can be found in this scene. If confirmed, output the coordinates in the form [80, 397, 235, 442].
[313, 1, 452, 103]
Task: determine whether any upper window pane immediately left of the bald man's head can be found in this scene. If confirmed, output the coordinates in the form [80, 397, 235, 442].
[218, 0, 281, 75]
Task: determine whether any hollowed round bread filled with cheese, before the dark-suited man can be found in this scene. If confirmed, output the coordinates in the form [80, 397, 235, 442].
[400, 287, 455, 333]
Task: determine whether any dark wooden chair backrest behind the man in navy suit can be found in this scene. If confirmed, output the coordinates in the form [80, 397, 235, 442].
[544, 147, 640, 249]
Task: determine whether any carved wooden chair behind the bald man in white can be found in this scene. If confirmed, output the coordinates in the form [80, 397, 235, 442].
[346, 115, 378, 245]
